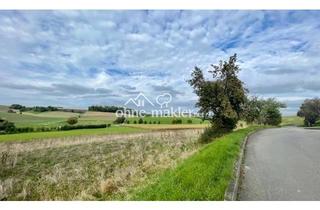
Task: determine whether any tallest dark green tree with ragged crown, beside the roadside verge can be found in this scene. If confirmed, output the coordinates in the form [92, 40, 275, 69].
[188, 54, 247, 132]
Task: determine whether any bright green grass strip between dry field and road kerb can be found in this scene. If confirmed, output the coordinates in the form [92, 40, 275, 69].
[132, 127, 261, 200]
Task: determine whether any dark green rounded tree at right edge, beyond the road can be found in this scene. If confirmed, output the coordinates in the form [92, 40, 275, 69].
[297, 98, 320, 126]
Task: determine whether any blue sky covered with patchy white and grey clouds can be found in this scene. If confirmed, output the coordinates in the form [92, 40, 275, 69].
[0, 10, 320, 115]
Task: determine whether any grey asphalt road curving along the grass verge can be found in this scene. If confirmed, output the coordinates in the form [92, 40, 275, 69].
[238, 127, 320, 201]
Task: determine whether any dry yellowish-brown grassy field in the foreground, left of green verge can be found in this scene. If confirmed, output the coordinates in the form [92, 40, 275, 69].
[0, 129, 202, 200]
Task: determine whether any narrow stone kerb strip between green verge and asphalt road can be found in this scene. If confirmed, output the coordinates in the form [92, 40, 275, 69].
[224, 129, 261, 201]
